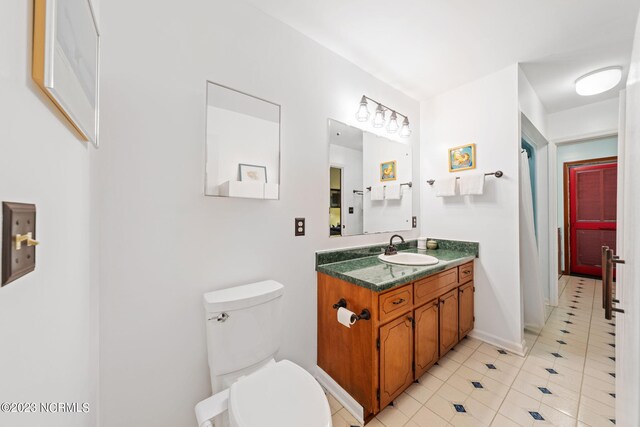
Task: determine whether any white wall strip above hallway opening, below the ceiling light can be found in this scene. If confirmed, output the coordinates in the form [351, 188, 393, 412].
[545, 97, 618, 143]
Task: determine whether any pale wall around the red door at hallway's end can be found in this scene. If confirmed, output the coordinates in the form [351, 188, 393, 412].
[556, 136, 618, 268]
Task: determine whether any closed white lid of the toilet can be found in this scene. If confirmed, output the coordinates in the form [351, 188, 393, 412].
[229, 360, 331, 427]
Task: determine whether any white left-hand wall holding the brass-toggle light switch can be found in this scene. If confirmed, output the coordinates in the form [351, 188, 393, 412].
[0, 2, 98, 427]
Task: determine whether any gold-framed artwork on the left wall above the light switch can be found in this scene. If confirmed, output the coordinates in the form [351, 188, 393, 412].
[31, 0, 100, 147]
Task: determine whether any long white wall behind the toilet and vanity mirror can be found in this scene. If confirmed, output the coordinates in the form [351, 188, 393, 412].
[99, 0, 420, 427]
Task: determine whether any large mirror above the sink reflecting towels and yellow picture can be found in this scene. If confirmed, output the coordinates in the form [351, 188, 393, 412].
[329, 119, 413, 236]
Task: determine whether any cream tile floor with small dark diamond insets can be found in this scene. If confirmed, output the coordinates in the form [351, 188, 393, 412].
[329, 277, 615, 427]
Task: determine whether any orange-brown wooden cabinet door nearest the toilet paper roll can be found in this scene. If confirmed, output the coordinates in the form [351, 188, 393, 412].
[380, 315, 413, 410]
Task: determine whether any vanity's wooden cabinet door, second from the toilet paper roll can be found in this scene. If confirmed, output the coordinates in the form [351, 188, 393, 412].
[413, 299, 439, 379]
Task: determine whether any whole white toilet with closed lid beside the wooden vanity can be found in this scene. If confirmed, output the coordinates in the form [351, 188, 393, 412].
[196, 280, 331, 427]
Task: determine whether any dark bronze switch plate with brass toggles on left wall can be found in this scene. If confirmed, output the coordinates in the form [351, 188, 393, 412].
[2, 202, 36, 286]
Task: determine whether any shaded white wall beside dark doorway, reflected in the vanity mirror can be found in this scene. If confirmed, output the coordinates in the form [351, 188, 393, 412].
[329, 145, 366, 236]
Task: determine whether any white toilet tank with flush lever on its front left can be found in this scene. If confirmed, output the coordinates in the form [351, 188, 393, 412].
[203, 280, 284, 392]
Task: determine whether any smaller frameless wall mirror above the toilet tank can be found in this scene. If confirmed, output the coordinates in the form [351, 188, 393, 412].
[204, 82, 280, 199]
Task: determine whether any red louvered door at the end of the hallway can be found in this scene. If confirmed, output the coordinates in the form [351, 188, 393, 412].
[569, 163, 618, 276]
